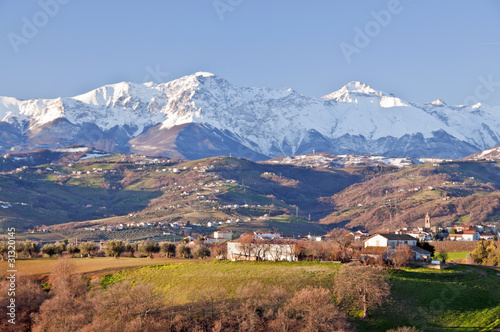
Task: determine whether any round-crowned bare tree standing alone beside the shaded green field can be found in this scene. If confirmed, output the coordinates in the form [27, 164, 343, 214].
[334, 265, 390, 319]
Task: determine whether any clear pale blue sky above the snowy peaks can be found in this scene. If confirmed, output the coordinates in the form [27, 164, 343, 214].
[0, 0, 500, 105]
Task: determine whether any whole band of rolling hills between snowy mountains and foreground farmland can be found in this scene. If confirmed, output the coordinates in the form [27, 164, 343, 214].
[0, 147, 500, 242]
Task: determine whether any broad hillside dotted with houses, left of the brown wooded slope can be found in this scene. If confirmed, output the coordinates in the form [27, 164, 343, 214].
[0, 155, 361, 240]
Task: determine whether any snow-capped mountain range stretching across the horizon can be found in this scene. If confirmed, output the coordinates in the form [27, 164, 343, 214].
[0, 72, 500, 160]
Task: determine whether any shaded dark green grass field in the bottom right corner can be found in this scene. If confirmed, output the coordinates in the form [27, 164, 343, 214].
[360, 265, 500, 332]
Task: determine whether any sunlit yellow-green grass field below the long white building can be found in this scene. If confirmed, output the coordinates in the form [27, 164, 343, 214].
[101, 260, 339, 306]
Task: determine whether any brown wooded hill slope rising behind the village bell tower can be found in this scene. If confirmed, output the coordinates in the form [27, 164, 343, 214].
[321, 161, 500, 231]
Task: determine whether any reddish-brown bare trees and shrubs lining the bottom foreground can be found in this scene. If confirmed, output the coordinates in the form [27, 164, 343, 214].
[0, 259, 415, 332]
